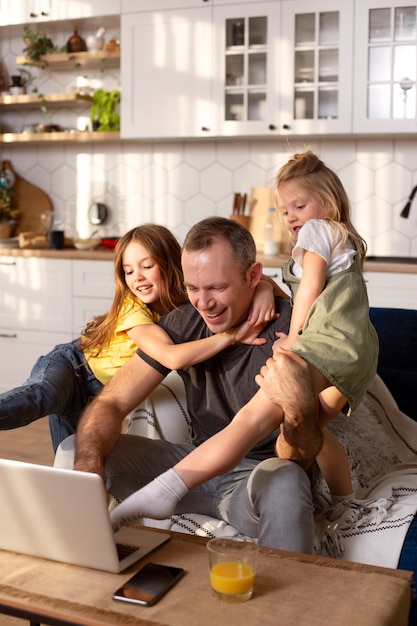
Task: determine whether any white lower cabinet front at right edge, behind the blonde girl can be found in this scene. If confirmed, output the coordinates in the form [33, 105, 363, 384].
[365, 272, 417, 308]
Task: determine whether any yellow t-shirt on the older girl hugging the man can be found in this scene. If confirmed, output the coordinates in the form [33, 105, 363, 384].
[85, 296, 161, 385]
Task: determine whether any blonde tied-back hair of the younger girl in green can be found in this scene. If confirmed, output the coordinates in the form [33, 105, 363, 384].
[275, 150, 367, 267]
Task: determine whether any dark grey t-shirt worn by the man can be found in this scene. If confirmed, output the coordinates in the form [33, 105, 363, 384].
[137, 296, 291, 460]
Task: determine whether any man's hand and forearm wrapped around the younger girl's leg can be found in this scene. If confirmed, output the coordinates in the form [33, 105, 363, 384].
[255, 350, 323, 469]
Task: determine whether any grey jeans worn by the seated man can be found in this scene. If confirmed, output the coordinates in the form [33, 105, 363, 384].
[106, 435, 314, 553]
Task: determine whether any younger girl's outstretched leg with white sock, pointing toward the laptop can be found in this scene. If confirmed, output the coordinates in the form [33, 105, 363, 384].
[111, 390, 282, 530]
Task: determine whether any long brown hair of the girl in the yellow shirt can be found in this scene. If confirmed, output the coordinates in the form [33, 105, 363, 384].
[81, 224, 187, 356]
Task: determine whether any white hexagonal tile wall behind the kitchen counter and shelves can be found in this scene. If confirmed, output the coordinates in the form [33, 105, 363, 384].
[0, 31, 417, 257]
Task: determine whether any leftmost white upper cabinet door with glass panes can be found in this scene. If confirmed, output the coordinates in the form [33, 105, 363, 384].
[213, 2, 280, 135]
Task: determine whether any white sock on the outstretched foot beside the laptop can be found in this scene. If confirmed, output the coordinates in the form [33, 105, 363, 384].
[110, 469, 189, 530]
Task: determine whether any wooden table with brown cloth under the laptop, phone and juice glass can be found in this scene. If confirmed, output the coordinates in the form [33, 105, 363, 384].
[0, 522, 412, 626]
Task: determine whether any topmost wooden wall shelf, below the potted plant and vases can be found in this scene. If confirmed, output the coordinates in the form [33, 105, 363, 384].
[16, 50, 120, 70]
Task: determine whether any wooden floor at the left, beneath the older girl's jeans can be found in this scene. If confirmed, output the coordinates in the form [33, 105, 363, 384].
[0, 418, 54, 626]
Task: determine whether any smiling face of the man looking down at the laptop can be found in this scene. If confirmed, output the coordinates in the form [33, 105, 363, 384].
[182, 240, 261, 333]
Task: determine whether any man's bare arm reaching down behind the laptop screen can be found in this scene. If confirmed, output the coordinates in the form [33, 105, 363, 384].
[74, 354, 164, 479]
